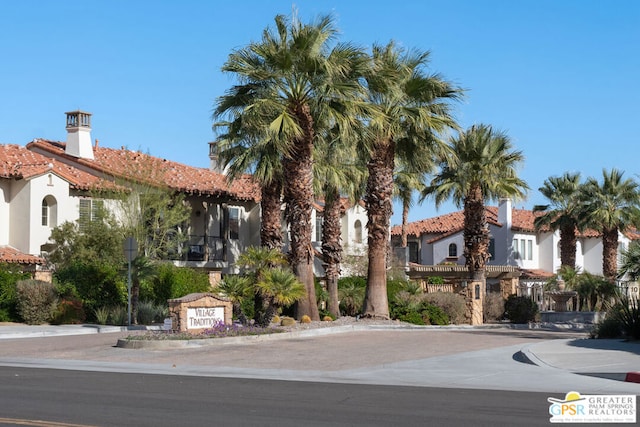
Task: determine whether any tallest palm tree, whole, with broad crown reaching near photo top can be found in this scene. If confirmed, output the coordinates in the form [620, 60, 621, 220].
[212, 15, 365, 320]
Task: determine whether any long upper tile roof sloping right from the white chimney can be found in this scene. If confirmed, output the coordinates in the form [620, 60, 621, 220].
[27, 139, 260, 201]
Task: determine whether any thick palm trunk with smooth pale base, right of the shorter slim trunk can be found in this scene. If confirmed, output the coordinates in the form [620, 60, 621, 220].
[363, 139, 395, 319]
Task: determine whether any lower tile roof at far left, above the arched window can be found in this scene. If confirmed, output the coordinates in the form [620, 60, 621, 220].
[0, 144, 122, 190]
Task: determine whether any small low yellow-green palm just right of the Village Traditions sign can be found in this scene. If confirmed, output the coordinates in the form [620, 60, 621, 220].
[256, 268, 307, 327]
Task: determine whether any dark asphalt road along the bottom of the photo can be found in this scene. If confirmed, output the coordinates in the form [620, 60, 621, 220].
[0, 367, 561, 427]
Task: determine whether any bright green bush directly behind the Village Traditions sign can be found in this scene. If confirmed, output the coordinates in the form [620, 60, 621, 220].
[149, 263, 211, 305]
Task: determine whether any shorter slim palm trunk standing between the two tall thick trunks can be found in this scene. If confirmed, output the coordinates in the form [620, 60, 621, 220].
[322, 188, 342, 318]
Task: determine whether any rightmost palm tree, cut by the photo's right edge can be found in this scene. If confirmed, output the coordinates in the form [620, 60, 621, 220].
[580, 169, 640, 282]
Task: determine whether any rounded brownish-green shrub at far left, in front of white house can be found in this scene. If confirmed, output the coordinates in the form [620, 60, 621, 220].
[16, 279, 57, 325]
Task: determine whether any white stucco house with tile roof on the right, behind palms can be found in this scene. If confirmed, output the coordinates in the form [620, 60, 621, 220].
[391, 199, 640, 299]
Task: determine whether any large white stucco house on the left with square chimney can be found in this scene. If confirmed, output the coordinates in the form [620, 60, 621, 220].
[0, 111, 366, 280]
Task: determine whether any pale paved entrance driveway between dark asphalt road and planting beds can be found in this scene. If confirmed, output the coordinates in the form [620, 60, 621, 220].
[0, 325, 640, 394]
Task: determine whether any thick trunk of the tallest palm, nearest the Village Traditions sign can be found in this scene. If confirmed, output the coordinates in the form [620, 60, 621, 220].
[283, 105, 320, 320]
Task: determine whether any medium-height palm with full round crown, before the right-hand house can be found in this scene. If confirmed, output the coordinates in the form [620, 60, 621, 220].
[425, 124, 529, 282]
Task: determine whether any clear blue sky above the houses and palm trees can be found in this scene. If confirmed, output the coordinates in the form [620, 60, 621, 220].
[0, 0, 640, 224]
